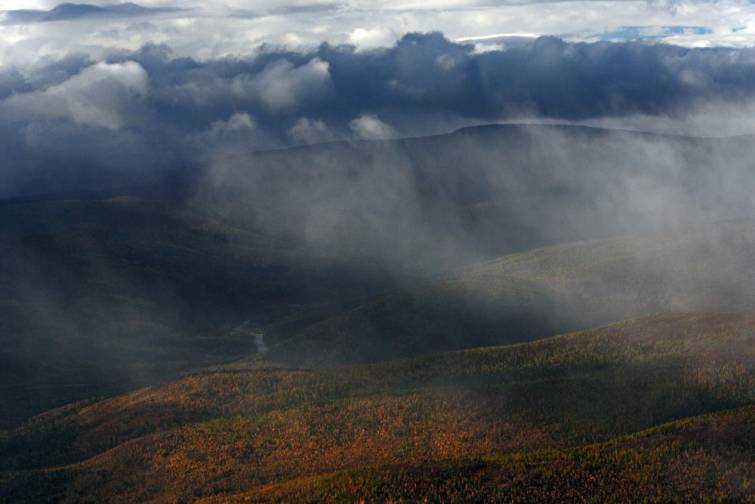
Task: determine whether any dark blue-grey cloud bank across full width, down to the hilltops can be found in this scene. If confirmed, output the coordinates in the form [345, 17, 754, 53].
[0, 33, 755, 196]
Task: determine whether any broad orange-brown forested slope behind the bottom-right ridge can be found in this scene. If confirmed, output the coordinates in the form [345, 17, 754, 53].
[0, 314, 755, 502]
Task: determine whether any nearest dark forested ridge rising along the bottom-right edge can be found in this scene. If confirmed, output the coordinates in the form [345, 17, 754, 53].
[221, 406, 755, 503]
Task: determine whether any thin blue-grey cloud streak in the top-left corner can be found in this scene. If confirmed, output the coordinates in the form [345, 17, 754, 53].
[2, 3, 179, 24]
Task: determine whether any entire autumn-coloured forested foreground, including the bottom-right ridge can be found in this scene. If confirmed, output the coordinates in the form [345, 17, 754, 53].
[0, 313, 755, 502]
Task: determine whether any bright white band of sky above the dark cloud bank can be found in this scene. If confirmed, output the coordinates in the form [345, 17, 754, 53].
[0, 0, 755, 64]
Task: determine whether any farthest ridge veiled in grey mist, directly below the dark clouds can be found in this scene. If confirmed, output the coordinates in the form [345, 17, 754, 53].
[202, 124, 755, 273]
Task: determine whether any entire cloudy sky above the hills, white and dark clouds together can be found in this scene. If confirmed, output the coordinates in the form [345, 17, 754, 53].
[0, 0, 755, 196]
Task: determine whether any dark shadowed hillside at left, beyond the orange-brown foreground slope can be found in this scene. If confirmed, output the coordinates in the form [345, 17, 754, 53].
[0, 195, 398, 425]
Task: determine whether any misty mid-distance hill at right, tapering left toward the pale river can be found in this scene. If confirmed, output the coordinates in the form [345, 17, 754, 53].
[266, 221, 755, 366]
